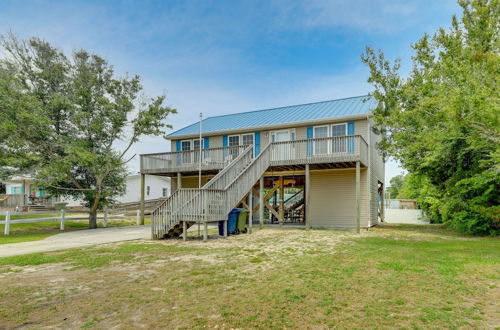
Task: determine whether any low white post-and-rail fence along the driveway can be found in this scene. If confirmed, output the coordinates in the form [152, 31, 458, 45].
[0, 210, 140, 235]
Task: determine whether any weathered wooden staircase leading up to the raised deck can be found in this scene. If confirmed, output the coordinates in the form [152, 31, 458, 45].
[151, 145, 270, 239]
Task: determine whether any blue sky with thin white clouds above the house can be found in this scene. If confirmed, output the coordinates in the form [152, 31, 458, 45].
[0, 0, 460, 183]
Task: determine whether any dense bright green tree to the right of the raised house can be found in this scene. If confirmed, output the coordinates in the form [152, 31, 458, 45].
[362, 0, 500, 235]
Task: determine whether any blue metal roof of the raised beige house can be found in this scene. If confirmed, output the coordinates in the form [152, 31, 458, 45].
[168, 95, 377, 137]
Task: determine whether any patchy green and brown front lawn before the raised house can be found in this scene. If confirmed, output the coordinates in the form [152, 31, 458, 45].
[0, 225, 500, 329]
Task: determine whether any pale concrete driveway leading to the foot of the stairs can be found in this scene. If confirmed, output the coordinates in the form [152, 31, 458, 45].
[0, 226, 151, 258]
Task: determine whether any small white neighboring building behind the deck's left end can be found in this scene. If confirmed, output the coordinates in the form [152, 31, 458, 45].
[117, 174, 170, 203]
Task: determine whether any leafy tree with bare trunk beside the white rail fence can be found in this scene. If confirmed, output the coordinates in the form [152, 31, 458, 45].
[0, 35, 176, 228]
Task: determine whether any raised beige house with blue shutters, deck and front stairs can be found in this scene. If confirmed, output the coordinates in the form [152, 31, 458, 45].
[141, 96, 384, 239]
